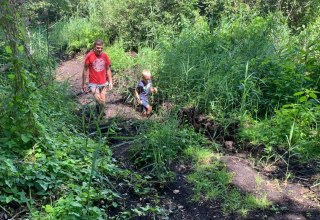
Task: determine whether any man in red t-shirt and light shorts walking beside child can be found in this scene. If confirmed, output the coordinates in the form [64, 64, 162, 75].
[82, 40, 113, 115]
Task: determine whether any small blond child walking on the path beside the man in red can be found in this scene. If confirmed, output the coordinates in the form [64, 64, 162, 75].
[135, 69, 157, 116]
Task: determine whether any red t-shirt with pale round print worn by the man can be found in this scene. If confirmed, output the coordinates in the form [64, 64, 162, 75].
[84, 51, 111, 84]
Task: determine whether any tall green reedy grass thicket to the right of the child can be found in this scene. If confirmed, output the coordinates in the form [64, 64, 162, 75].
[159, 12, 299, 117]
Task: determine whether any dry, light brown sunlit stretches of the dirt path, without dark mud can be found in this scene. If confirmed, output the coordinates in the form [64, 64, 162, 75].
[56, 56, 320, 219]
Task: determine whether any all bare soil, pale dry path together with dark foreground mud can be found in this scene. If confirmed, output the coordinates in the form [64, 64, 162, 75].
[56, 56, 320, 220]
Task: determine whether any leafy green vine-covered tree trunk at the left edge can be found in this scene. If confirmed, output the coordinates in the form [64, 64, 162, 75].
[0, 1, 45, 152]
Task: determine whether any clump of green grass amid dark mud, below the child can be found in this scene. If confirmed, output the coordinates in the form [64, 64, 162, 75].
[131, 118, 204, 181]
